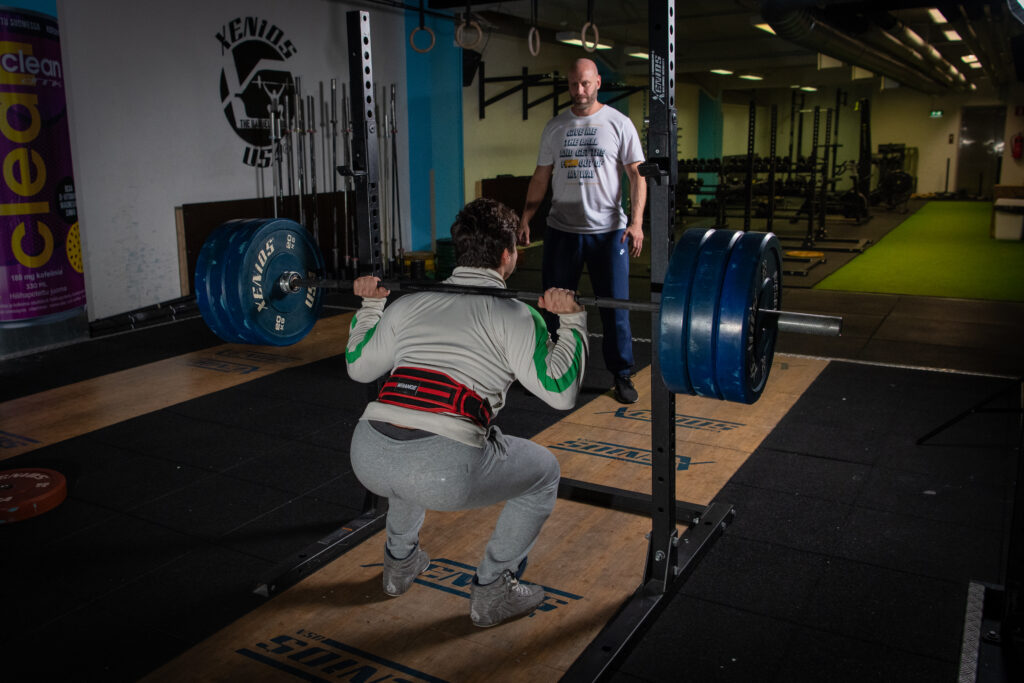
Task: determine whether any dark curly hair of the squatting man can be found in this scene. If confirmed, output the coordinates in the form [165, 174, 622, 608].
[452, 198, 519, 268]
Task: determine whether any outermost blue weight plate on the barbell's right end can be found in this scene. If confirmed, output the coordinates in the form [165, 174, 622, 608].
[715, 232, 782, 403]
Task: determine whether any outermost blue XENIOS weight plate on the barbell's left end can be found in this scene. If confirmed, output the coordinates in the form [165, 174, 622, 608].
[224, 218, 324, 346]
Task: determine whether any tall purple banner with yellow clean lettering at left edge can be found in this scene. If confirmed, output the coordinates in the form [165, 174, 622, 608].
[0, 9, 85, 323]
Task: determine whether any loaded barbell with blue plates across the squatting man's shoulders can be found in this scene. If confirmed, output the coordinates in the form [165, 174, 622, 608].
[195, 218, 842, 403]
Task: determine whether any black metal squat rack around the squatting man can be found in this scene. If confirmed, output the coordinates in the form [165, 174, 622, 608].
[254, 0, 735, 681]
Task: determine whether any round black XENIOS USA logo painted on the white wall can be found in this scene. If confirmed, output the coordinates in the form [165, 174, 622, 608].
[216, 16, 296, 167]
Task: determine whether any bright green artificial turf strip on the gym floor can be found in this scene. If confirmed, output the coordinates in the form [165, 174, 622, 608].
[814, 202, 1024, 301]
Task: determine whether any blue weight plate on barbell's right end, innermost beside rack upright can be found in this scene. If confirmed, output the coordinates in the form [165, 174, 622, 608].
[657, 228, 715, 393]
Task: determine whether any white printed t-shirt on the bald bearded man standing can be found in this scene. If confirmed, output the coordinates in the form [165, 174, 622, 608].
[537, 105, 643, 232]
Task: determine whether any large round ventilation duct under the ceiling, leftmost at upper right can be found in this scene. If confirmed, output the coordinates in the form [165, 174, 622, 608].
[761, 0, 946, 94]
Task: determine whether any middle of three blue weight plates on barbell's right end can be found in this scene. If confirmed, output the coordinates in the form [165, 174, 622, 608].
[686, 230, 743, 398]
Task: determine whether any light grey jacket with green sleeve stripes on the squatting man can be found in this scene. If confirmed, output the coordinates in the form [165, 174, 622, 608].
[345, 267, 588, 445]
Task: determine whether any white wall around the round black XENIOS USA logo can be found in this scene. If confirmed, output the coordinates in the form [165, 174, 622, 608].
[57, 0, 410, 319]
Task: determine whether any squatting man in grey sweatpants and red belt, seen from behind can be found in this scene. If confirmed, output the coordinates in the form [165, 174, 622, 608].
[345, 199, 588, 627]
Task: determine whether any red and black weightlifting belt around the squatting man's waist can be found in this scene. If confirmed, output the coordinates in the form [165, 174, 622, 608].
[377, 368, 493, 427]
